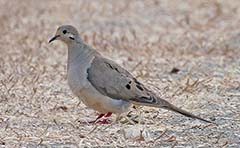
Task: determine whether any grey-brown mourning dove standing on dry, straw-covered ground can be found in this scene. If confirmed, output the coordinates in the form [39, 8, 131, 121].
[49, 25, 212, 123]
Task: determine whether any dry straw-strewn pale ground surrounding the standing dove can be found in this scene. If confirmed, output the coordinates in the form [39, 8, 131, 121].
[0, 0, 240, 148]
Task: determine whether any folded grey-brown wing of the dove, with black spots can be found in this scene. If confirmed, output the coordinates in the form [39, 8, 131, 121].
[87, 56, 159, 104]
